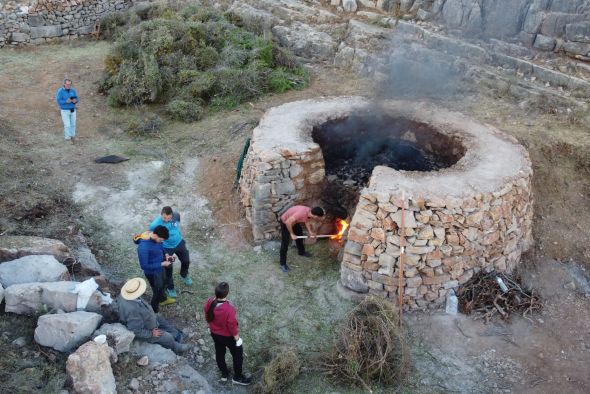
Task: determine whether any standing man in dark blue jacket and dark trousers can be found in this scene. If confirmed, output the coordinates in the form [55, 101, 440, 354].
[137, 226, 176, 313]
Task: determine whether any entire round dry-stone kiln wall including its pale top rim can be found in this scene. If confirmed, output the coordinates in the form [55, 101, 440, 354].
[241, 97, 533, 308]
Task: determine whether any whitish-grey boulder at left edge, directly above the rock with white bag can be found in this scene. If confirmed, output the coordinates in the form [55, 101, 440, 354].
[0, 255, 68, 287]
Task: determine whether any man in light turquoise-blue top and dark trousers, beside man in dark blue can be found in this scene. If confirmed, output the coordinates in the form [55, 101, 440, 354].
[150, 207, 193, 298]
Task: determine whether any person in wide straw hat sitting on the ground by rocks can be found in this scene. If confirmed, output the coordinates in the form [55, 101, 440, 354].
[117, 278, 189, 354]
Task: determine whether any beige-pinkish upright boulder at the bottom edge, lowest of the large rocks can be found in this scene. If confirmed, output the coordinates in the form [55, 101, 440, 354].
[66, 341, 117, 394]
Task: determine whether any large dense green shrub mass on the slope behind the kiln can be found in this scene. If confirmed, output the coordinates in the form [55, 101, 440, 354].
[99, 4, 309, 121]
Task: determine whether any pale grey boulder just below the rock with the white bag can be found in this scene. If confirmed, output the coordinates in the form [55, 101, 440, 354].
[35, 311, 102, 352]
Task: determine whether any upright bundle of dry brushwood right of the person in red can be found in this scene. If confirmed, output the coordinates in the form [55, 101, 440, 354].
[322, 297, 410, 392]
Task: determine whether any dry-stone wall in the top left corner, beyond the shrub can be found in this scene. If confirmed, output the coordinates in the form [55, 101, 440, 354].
[0, 0, 141, 47]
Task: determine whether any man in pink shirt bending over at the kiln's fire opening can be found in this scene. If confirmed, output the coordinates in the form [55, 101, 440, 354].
[279, 205, 324, 272]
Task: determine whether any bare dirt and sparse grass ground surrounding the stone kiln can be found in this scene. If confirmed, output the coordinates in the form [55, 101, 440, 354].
[0, 37, 590, 393]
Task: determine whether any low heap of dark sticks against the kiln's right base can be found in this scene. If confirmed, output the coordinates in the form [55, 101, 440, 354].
[457, 271, 543, 323]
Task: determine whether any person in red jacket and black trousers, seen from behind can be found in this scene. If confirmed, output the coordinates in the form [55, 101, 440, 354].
[203, 282, 252, 386]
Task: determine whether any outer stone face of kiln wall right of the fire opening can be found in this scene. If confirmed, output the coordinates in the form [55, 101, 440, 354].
[341, 167, 533, 308]
